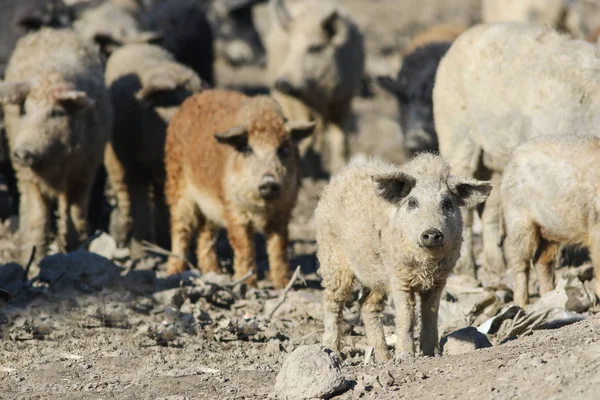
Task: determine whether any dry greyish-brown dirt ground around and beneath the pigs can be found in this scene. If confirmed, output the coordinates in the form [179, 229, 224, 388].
[0, 0, 600, 399]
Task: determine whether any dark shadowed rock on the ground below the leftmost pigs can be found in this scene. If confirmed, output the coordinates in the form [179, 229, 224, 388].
[39, 250, 121, 292]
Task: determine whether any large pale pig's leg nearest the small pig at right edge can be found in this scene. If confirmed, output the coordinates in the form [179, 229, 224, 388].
[481, 173, 506, 274]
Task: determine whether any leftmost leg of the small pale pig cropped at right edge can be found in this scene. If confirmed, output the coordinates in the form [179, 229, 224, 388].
[505, 219, 539, 307]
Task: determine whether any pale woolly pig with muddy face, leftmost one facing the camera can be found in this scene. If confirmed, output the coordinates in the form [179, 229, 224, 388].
[0, 28, 113, 262]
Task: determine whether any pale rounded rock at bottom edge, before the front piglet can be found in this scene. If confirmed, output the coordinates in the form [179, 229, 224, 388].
[275, 345, 347, 400]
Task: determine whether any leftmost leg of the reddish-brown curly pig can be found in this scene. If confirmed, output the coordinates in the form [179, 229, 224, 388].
[167, 193, 198, 275]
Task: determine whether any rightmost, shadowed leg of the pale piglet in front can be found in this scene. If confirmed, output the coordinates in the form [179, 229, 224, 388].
[420, 281, 446, 356]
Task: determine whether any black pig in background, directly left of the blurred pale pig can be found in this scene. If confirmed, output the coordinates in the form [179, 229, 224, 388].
[144, 0, 215, 85]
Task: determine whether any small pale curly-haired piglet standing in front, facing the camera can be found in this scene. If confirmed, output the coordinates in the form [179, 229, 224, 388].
[315, 153, 492, 361]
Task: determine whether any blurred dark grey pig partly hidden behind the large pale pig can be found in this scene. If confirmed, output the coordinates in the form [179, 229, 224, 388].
[377, 42, 452, 157]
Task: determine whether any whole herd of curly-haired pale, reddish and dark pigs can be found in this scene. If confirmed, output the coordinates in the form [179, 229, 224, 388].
[0, 0, 600, 376]
